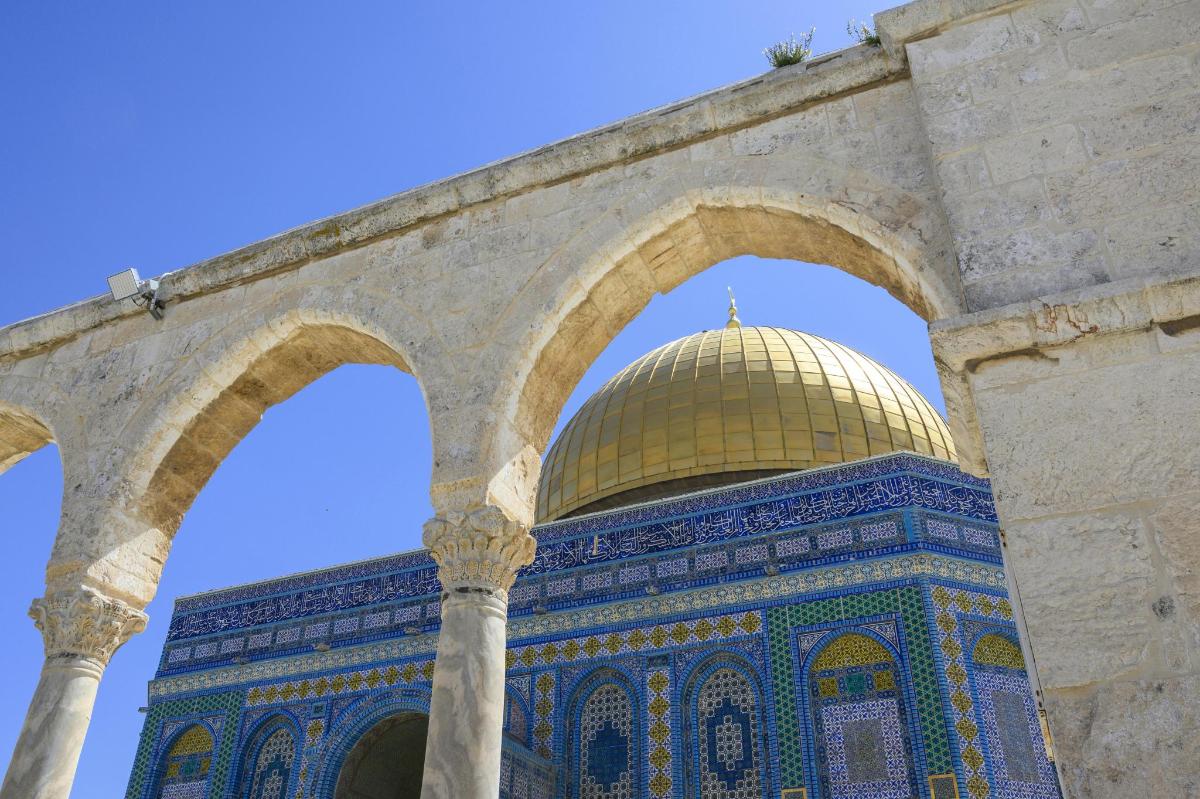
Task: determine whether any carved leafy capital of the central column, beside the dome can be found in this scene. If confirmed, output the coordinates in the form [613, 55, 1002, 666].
[422, 505, 538, 593]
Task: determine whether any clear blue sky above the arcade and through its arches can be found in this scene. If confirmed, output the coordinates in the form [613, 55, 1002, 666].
[0, 0, 926, 798]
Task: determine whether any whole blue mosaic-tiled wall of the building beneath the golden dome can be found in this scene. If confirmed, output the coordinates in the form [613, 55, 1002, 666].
[130, 456, 1057, 799]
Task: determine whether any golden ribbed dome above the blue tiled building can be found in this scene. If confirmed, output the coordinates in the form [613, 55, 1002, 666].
[536, 326, 956, 522]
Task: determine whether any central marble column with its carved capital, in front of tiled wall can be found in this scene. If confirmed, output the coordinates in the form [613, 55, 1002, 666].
[421, 506, 536, 799]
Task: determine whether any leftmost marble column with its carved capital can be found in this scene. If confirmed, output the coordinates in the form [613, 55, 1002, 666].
[0, 587, 146, 799]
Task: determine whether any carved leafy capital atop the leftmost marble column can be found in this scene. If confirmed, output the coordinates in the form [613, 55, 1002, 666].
[29, 587, 146, 668]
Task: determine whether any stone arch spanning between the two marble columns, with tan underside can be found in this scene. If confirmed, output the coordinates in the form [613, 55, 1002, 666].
[55, 302, 432, 605]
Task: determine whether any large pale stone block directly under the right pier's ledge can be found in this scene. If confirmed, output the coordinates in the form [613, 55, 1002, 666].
[976, 338, 1200, 519]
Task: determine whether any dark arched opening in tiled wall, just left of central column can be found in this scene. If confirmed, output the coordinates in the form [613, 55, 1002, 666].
[332, 713, 430, 799]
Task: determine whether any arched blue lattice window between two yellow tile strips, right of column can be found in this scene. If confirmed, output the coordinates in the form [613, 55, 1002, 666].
[566, 667, 642, 799]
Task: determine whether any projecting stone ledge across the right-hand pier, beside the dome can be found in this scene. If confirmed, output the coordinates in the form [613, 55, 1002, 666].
[929, 270, 1200, 373]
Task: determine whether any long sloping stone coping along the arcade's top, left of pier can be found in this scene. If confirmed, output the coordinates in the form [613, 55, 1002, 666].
[0, 40, 906, 359]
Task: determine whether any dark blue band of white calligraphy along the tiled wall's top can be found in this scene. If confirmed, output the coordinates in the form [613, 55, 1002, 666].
[164, 455, 996, 647]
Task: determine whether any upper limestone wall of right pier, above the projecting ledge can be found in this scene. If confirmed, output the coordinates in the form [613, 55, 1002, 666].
[907, 0, 1200, 311]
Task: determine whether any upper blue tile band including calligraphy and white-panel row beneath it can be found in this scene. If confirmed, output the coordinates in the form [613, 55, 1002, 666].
[158, 455, 1000, 675]
